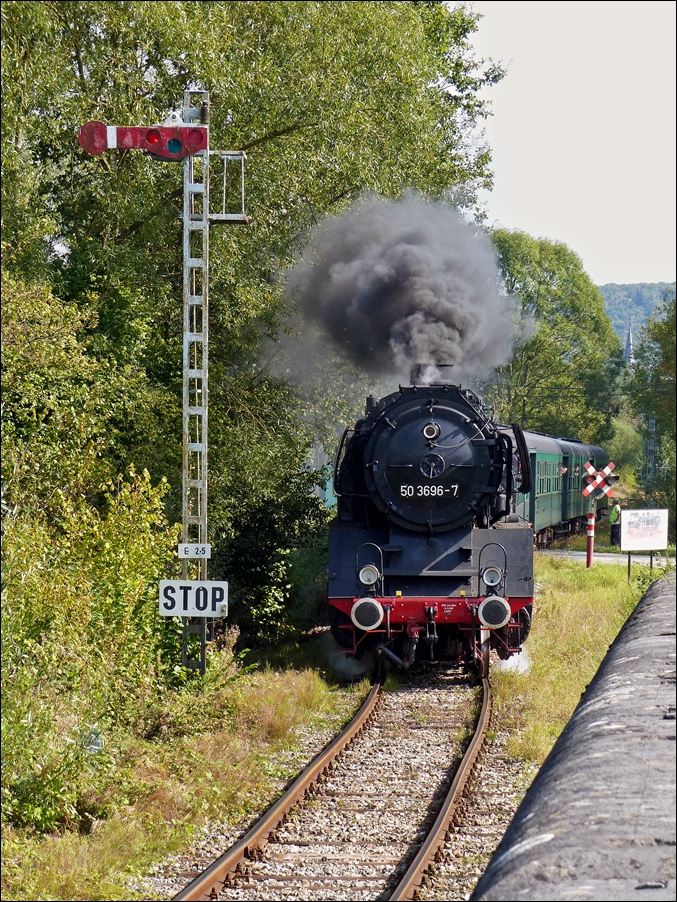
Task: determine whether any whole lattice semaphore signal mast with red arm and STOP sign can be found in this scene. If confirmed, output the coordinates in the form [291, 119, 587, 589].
[78, 89, 248, 673]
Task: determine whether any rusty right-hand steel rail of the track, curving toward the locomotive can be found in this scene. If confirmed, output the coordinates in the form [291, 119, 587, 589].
[390, 678, 491, 902]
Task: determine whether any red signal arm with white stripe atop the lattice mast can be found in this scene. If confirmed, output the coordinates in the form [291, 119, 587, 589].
[78, 122, 209, 160]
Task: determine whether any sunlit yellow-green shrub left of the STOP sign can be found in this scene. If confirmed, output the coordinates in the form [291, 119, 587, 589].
[2, 472, 177, 830]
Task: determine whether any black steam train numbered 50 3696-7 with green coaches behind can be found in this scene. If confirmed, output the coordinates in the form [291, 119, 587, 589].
[329, 367, 609, 675]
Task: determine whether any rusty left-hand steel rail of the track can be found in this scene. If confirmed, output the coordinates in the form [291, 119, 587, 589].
[174, 683, 382, 902]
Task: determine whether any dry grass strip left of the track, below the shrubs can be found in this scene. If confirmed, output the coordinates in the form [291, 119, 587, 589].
[2, 652, 369, 900]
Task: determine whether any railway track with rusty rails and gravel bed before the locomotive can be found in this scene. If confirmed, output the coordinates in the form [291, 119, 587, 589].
[174, 666, 490, 902]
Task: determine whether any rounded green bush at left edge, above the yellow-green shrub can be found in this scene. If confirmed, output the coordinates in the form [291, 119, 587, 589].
[1, 272, 180, 515]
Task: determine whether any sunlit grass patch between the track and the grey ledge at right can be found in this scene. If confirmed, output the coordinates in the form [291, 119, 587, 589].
[492, 555, 661, 764]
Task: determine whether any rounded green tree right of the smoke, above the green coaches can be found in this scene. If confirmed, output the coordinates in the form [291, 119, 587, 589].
[485, 229, 623, 443]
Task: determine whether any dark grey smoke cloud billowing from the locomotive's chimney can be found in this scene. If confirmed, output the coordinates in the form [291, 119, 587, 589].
[288, 194, 515, 381]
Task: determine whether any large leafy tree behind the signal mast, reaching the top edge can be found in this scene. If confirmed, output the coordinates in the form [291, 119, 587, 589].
[2, 0, 502, 636]
